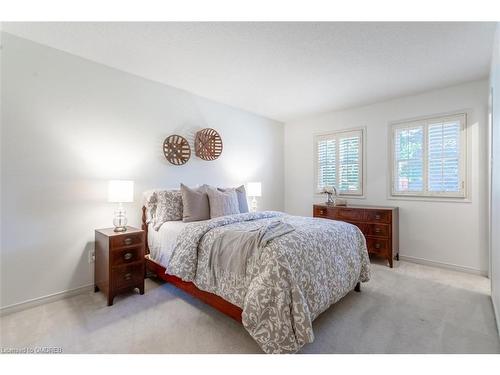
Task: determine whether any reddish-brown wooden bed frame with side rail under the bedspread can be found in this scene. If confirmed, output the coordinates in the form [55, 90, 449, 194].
[142, 207, 361, 323]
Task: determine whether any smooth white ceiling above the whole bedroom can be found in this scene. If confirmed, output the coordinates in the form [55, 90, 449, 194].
[2, 22, 495, 121]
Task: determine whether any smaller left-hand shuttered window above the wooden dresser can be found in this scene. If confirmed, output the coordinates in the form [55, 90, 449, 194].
[314, 130, 363, 195]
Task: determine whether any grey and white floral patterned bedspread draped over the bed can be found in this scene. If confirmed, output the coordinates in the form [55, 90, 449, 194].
[167, 211, 370, 353]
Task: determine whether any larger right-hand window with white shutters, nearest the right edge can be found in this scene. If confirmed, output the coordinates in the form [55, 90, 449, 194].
[391, 114, 466, 198]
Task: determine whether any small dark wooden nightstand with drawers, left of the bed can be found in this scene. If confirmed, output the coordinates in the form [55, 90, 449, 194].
[94, 227, 145, 306]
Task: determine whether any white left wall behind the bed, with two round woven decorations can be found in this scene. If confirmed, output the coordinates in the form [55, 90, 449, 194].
[1, 33, 284, 307]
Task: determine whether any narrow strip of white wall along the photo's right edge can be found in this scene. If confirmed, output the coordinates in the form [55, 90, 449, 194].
[490, 24, 500, 333]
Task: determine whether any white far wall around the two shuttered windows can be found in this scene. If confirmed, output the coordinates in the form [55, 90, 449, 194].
[285, 80, 488, 273]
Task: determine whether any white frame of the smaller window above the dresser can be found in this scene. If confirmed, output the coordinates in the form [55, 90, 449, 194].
[313, 127, 366, 199]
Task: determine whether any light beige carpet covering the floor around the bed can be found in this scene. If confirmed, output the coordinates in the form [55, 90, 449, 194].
[0, 262, 500, 353]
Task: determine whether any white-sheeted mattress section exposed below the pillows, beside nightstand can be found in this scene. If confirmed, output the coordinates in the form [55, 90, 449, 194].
[148, 220, 189, 268]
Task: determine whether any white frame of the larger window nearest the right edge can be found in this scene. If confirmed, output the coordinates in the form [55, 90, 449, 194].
[389, 111, 469, 201]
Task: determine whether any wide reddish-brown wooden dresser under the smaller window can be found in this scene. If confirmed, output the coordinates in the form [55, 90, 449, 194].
[313, 204, 399, 268]
